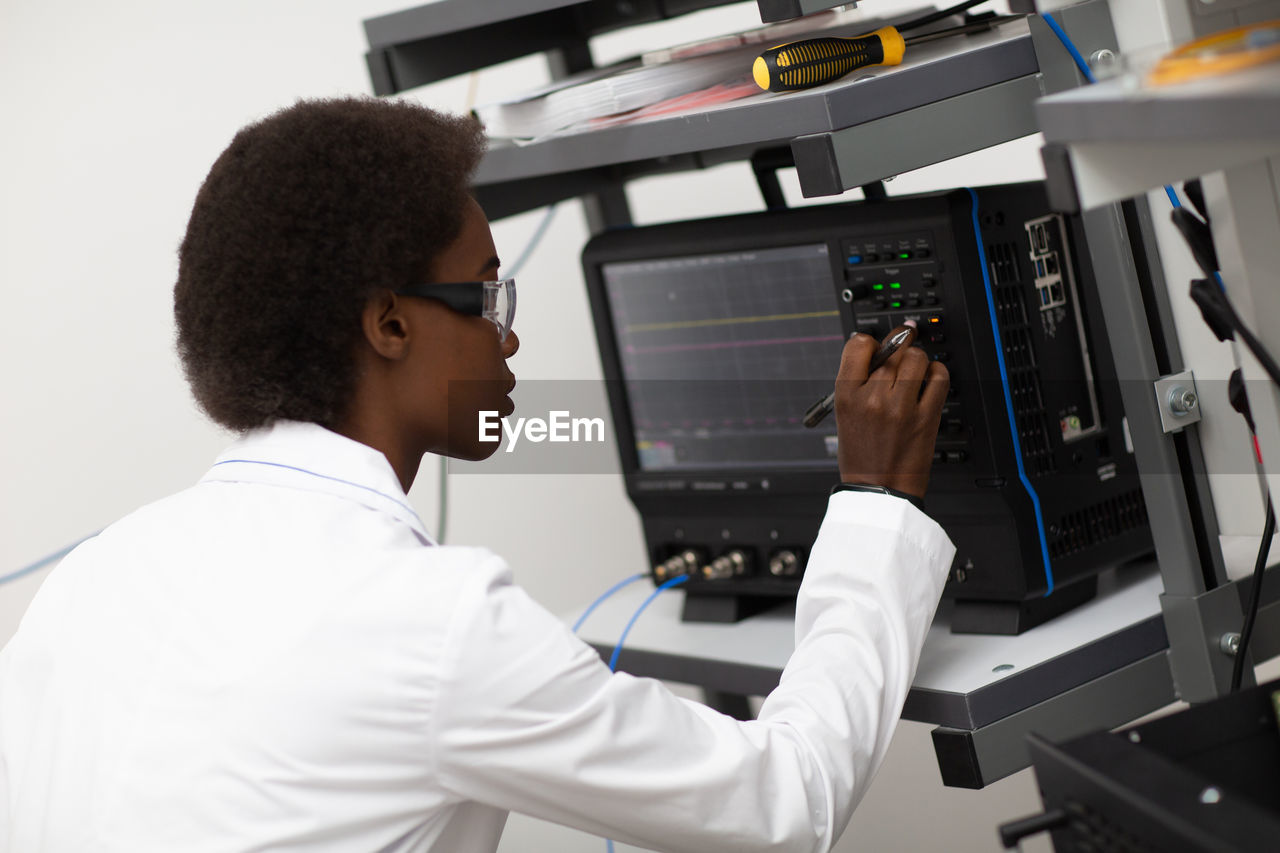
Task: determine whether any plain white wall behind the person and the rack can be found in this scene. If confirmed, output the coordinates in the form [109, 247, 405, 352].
[0, 0, 1259, 853]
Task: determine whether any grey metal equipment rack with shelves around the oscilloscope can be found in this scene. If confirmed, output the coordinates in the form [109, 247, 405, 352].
[365, 0, 1280, 788]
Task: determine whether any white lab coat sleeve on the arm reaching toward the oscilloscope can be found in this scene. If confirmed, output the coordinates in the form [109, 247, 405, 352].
[429, 492, 954, 853]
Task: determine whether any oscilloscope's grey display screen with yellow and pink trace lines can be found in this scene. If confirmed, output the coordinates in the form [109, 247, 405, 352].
[602, 243, 845, 471]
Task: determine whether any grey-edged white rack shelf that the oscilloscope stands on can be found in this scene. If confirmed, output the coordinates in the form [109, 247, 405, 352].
[576, 562, 1175, 788]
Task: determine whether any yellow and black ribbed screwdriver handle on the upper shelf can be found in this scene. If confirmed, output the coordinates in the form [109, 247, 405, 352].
[751, 27, 906, 92]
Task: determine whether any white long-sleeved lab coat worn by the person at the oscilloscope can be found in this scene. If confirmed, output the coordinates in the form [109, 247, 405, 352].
[0, 423, 954, 853]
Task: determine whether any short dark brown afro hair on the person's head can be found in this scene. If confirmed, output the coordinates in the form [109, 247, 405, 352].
[174, 97, 485, 432]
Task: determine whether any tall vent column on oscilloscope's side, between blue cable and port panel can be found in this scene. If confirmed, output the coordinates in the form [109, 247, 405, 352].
[987, 258, 1057, 476]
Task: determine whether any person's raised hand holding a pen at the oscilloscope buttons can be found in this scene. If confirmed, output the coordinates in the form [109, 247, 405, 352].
[836, 325, 951, 498]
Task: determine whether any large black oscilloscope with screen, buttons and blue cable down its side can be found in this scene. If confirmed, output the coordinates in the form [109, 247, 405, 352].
[582, 182, 1152, 634]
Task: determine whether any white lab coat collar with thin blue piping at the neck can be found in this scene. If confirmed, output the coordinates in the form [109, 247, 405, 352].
[201, 420, 435, 544]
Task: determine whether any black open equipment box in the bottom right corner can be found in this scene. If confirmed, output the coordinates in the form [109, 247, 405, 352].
[1001, 681, 1280, 853]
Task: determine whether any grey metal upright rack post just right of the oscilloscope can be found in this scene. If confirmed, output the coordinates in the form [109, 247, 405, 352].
[1032, 0, 1242, 702]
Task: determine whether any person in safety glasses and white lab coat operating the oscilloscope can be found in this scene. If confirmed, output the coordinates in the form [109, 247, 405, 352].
[0, 99, 954, 853]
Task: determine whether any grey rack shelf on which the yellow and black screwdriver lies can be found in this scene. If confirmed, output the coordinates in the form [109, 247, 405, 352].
[476, 22, 1042, 218]
